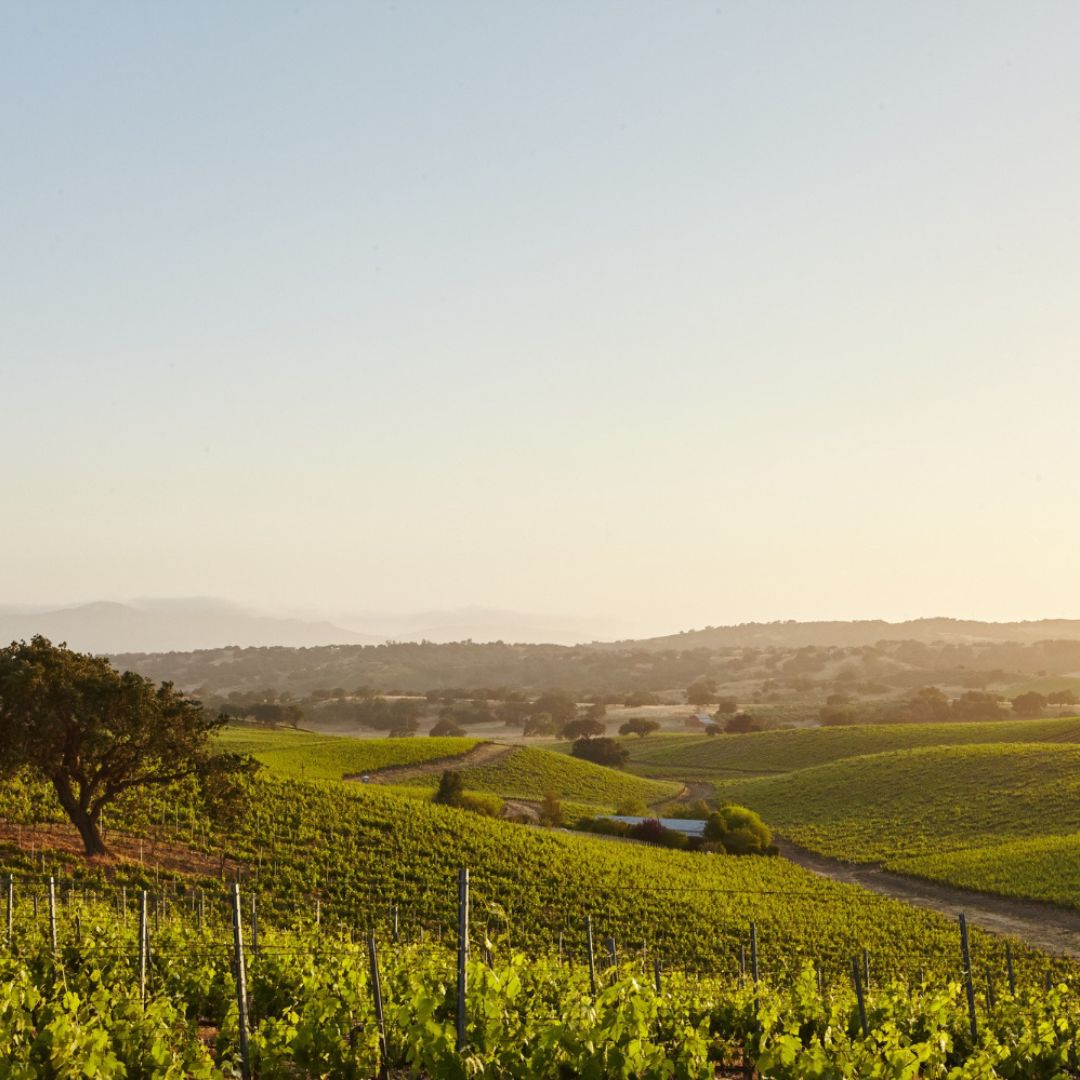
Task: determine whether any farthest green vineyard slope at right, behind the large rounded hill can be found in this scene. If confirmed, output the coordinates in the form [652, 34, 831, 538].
[623, 717, 1080, 780]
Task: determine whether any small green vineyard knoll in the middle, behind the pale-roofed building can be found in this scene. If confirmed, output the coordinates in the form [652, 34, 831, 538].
[397, 746, 681, 809]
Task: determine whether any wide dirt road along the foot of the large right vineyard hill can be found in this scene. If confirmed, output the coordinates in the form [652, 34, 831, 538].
[773, 836, 1080, 957]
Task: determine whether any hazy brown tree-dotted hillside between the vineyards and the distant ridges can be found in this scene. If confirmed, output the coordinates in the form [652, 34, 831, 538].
[105, 635, 1080, 699]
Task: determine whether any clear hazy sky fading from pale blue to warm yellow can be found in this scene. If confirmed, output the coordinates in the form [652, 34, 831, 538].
[0, 0, 1080, 632]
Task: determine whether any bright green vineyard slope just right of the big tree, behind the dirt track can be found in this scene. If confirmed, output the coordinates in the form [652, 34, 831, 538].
[217, 727, 480, 780]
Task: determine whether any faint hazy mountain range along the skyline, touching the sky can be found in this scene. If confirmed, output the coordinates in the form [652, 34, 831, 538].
[6, 597, 1080, 653]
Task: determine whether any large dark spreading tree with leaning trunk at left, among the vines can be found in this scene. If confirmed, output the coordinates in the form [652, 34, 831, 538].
[0, 636, 241, 855]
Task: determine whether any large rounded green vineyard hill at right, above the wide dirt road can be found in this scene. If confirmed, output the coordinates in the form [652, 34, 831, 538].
[720, 743, 1080, 905]
